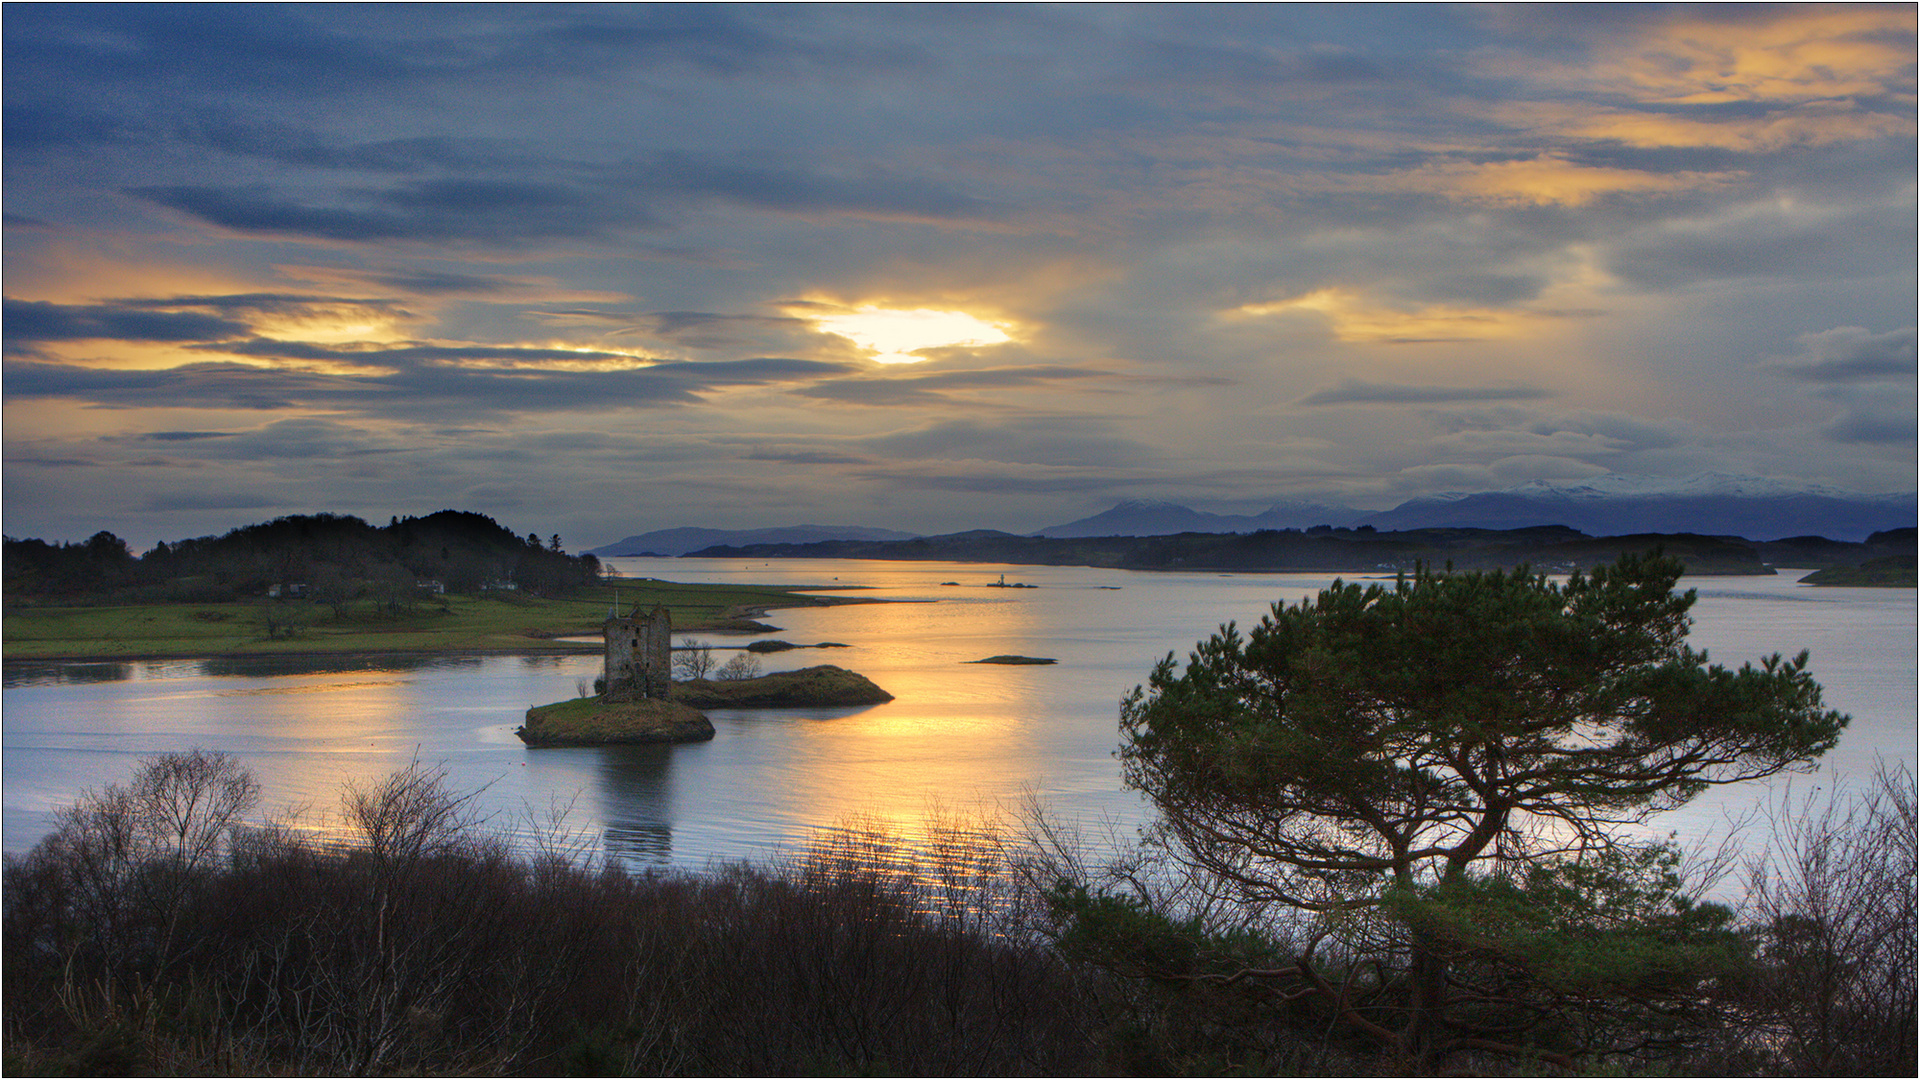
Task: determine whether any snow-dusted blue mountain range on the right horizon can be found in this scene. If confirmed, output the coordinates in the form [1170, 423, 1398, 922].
[1361, 473, 1916, 542]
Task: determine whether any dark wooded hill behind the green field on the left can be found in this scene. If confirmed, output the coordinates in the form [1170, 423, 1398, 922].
[6, 509, 601, 601]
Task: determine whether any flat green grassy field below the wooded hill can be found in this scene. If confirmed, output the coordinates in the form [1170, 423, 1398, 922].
[0, 580, 867, 659]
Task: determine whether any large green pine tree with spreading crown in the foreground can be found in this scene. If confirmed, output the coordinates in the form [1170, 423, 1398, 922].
[1121, 555, 1847, 1065]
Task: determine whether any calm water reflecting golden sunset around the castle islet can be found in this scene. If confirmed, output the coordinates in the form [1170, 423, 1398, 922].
[4, 559, 1916, 867]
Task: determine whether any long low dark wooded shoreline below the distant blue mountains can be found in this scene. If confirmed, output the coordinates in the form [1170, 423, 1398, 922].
[693, 525, 1914, 575]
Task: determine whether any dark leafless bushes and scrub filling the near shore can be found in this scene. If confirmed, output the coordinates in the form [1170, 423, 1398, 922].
[4, 751, 1914, 1076]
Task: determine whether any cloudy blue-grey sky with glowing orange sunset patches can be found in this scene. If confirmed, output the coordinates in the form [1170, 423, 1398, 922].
[0, 4, 1920, 550]
